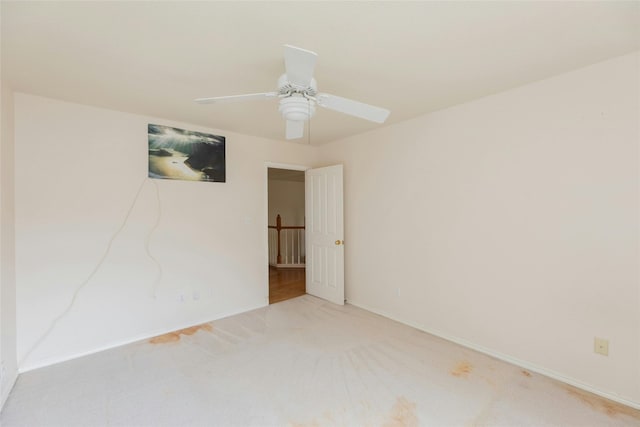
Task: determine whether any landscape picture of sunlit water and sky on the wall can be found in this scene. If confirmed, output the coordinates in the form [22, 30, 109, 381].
[148, 124, 226, 182]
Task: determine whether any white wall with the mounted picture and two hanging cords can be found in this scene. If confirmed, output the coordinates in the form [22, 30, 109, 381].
[15, 94, 316, 371]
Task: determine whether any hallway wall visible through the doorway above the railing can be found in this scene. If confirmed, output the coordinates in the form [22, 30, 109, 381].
[269, 180, 304, 226]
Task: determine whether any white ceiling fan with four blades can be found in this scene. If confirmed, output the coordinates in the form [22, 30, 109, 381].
[195, 45, 390, 139]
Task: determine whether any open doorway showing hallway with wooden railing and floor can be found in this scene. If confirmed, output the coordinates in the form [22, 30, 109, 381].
[267, 167, 306, 304]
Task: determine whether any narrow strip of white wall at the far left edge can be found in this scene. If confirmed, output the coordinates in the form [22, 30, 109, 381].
[0, 84, 18, 408]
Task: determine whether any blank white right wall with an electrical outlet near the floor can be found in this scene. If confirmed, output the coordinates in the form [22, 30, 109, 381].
[319, 54, 640, 404]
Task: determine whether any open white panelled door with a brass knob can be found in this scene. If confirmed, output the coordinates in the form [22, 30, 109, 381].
[305, 165, 344, 305]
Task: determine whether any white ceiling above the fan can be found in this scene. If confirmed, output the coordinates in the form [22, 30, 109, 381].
[1, 1, 640, 144]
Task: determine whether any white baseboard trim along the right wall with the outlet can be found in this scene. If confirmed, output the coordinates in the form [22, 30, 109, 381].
[347, 300, 640, 409]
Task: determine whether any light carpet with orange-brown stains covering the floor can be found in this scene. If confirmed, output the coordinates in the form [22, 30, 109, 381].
[0, 295, 640, 427]
